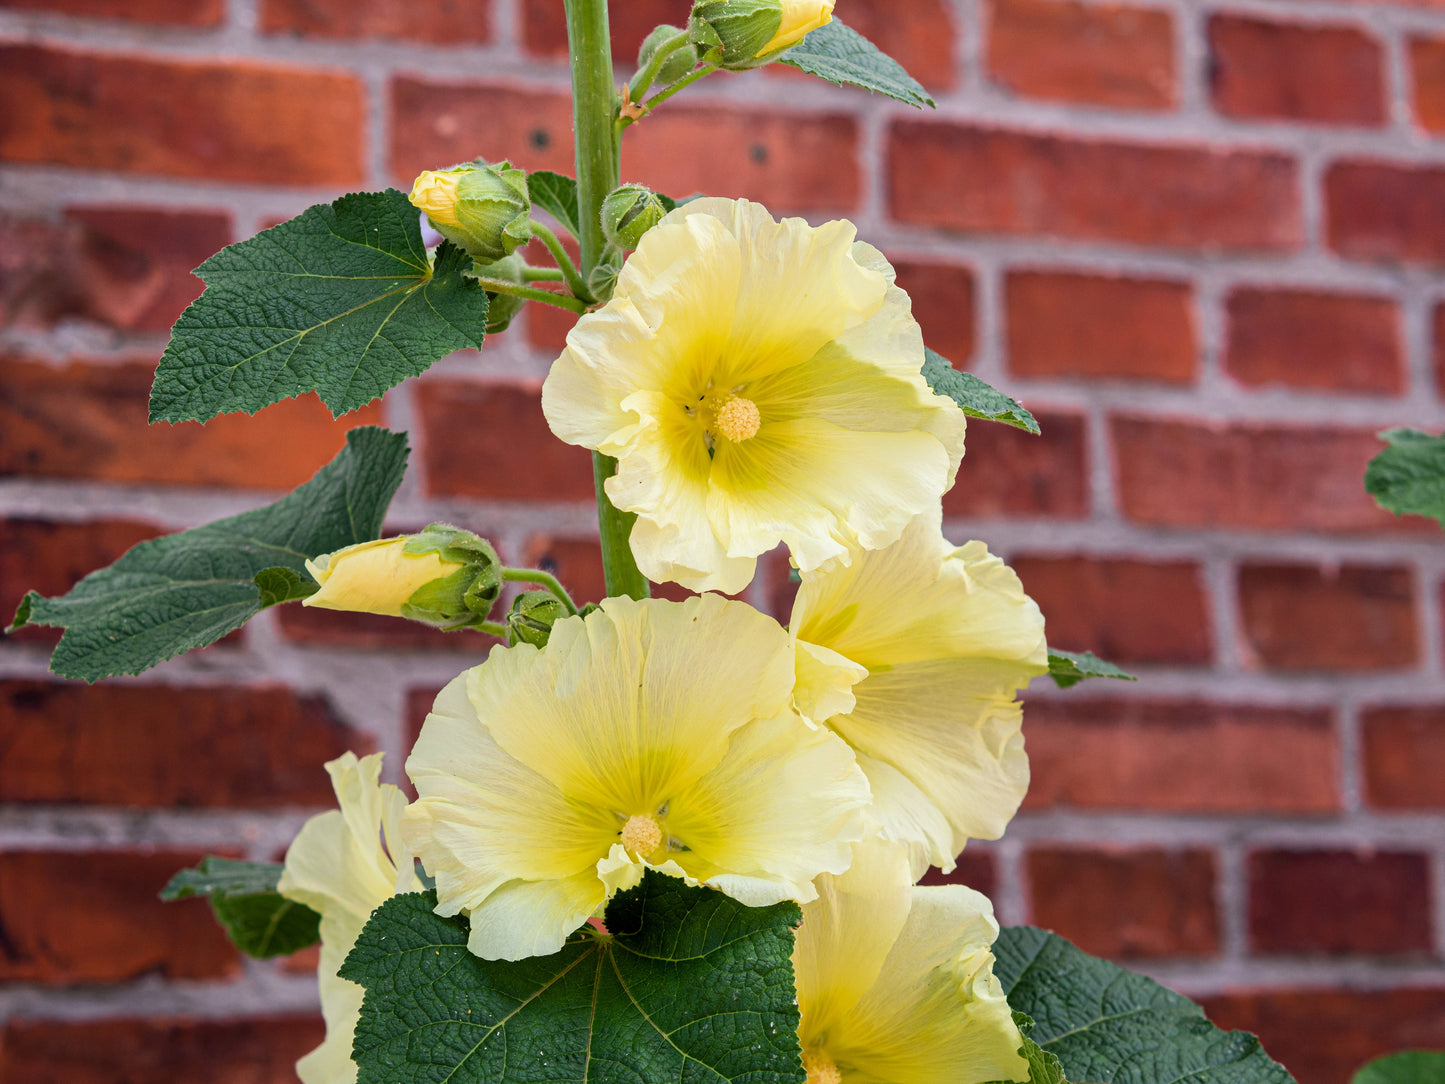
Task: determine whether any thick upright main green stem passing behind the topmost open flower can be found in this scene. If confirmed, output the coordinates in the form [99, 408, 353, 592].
[565, 0, 649, 598]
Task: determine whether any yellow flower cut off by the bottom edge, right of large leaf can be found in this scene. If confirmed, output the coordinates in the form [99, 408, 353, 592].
[793, 840, 1029, 1084]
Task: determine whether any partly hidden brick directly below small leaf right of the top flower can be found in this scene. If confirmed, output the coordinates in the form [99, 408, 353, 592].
[944, 410, 1090, 519]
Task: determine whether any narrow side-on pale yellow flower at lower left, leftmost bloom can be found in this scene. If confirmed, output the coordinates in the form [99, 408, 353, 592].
[276, 753, 422, 1084]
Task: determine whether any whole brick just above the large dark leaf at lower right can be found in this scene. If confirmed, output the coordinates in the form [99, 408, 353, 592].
[1026, 847, 1220, 960]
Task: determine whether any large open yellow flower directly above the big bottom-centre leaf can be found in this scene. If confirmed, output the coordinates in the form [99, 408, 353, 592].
[402, 594, 868, 960]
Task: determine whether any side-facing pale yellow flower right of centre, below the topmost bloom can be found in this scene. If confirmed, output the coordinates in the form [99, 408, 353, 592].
[789, 507, 1048, 874]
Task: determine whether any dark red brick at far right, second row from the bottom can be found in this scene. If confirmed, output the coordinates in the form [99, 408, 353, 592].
[1248, 850, 1432, 955]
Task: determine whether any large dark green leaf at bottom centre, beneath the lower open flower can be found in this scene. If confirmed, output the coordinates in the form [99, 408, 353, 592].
[341, 870, 803, 1084]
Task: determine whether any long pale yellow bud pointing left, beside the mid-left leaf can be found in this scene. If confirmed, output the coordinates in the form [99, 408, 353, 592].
[302, 523, 501, 629]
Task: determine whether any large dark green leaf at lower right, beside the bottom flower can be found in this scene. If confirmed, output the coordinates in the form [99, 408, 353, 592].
[994, 926, 1293, 1084]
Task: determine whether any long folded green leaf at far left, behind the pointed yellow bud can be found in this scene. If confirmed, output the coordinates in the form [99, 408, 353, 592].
[16, 428, 407, 681]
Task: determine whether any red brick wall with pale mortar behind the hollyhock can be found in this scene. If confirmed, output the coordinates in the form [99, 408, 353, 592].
[0, 0, 1445, 1084]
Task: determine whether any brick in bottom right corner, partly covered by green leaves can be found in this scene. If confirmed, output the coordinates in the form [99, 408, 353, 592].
[1204, 987, 1445, 1084]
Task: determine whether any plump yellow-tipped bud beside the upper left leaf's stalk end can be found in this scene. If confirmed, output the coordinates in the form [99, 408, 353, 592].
[410, 162, 532, 264]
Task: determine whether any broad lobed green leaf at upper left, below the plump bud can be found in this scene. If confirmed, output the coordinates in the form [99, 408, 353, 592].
[150, 188, 487, 422]
